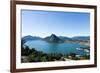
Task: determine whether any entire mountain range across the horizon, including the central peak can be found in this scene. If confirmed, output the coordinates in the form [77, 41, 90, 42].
[22, 34, 90, 43]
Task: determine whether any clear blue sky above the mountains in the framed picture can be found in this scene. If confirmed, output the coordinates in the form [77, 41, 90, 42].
[21, 10, 90, 37]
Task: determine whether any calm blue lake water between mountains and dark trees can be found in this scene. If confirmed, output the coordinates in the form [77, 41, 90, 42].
[24, 40, 88, 55]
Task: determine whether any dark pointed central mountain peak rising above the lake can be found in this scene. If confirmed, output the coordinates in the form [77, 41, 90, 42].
[44, 34, 64, 43]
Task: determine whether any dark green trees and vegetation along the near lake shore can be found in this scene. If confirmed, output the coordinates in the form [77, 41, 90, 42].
[21, 46, 90, 62]
